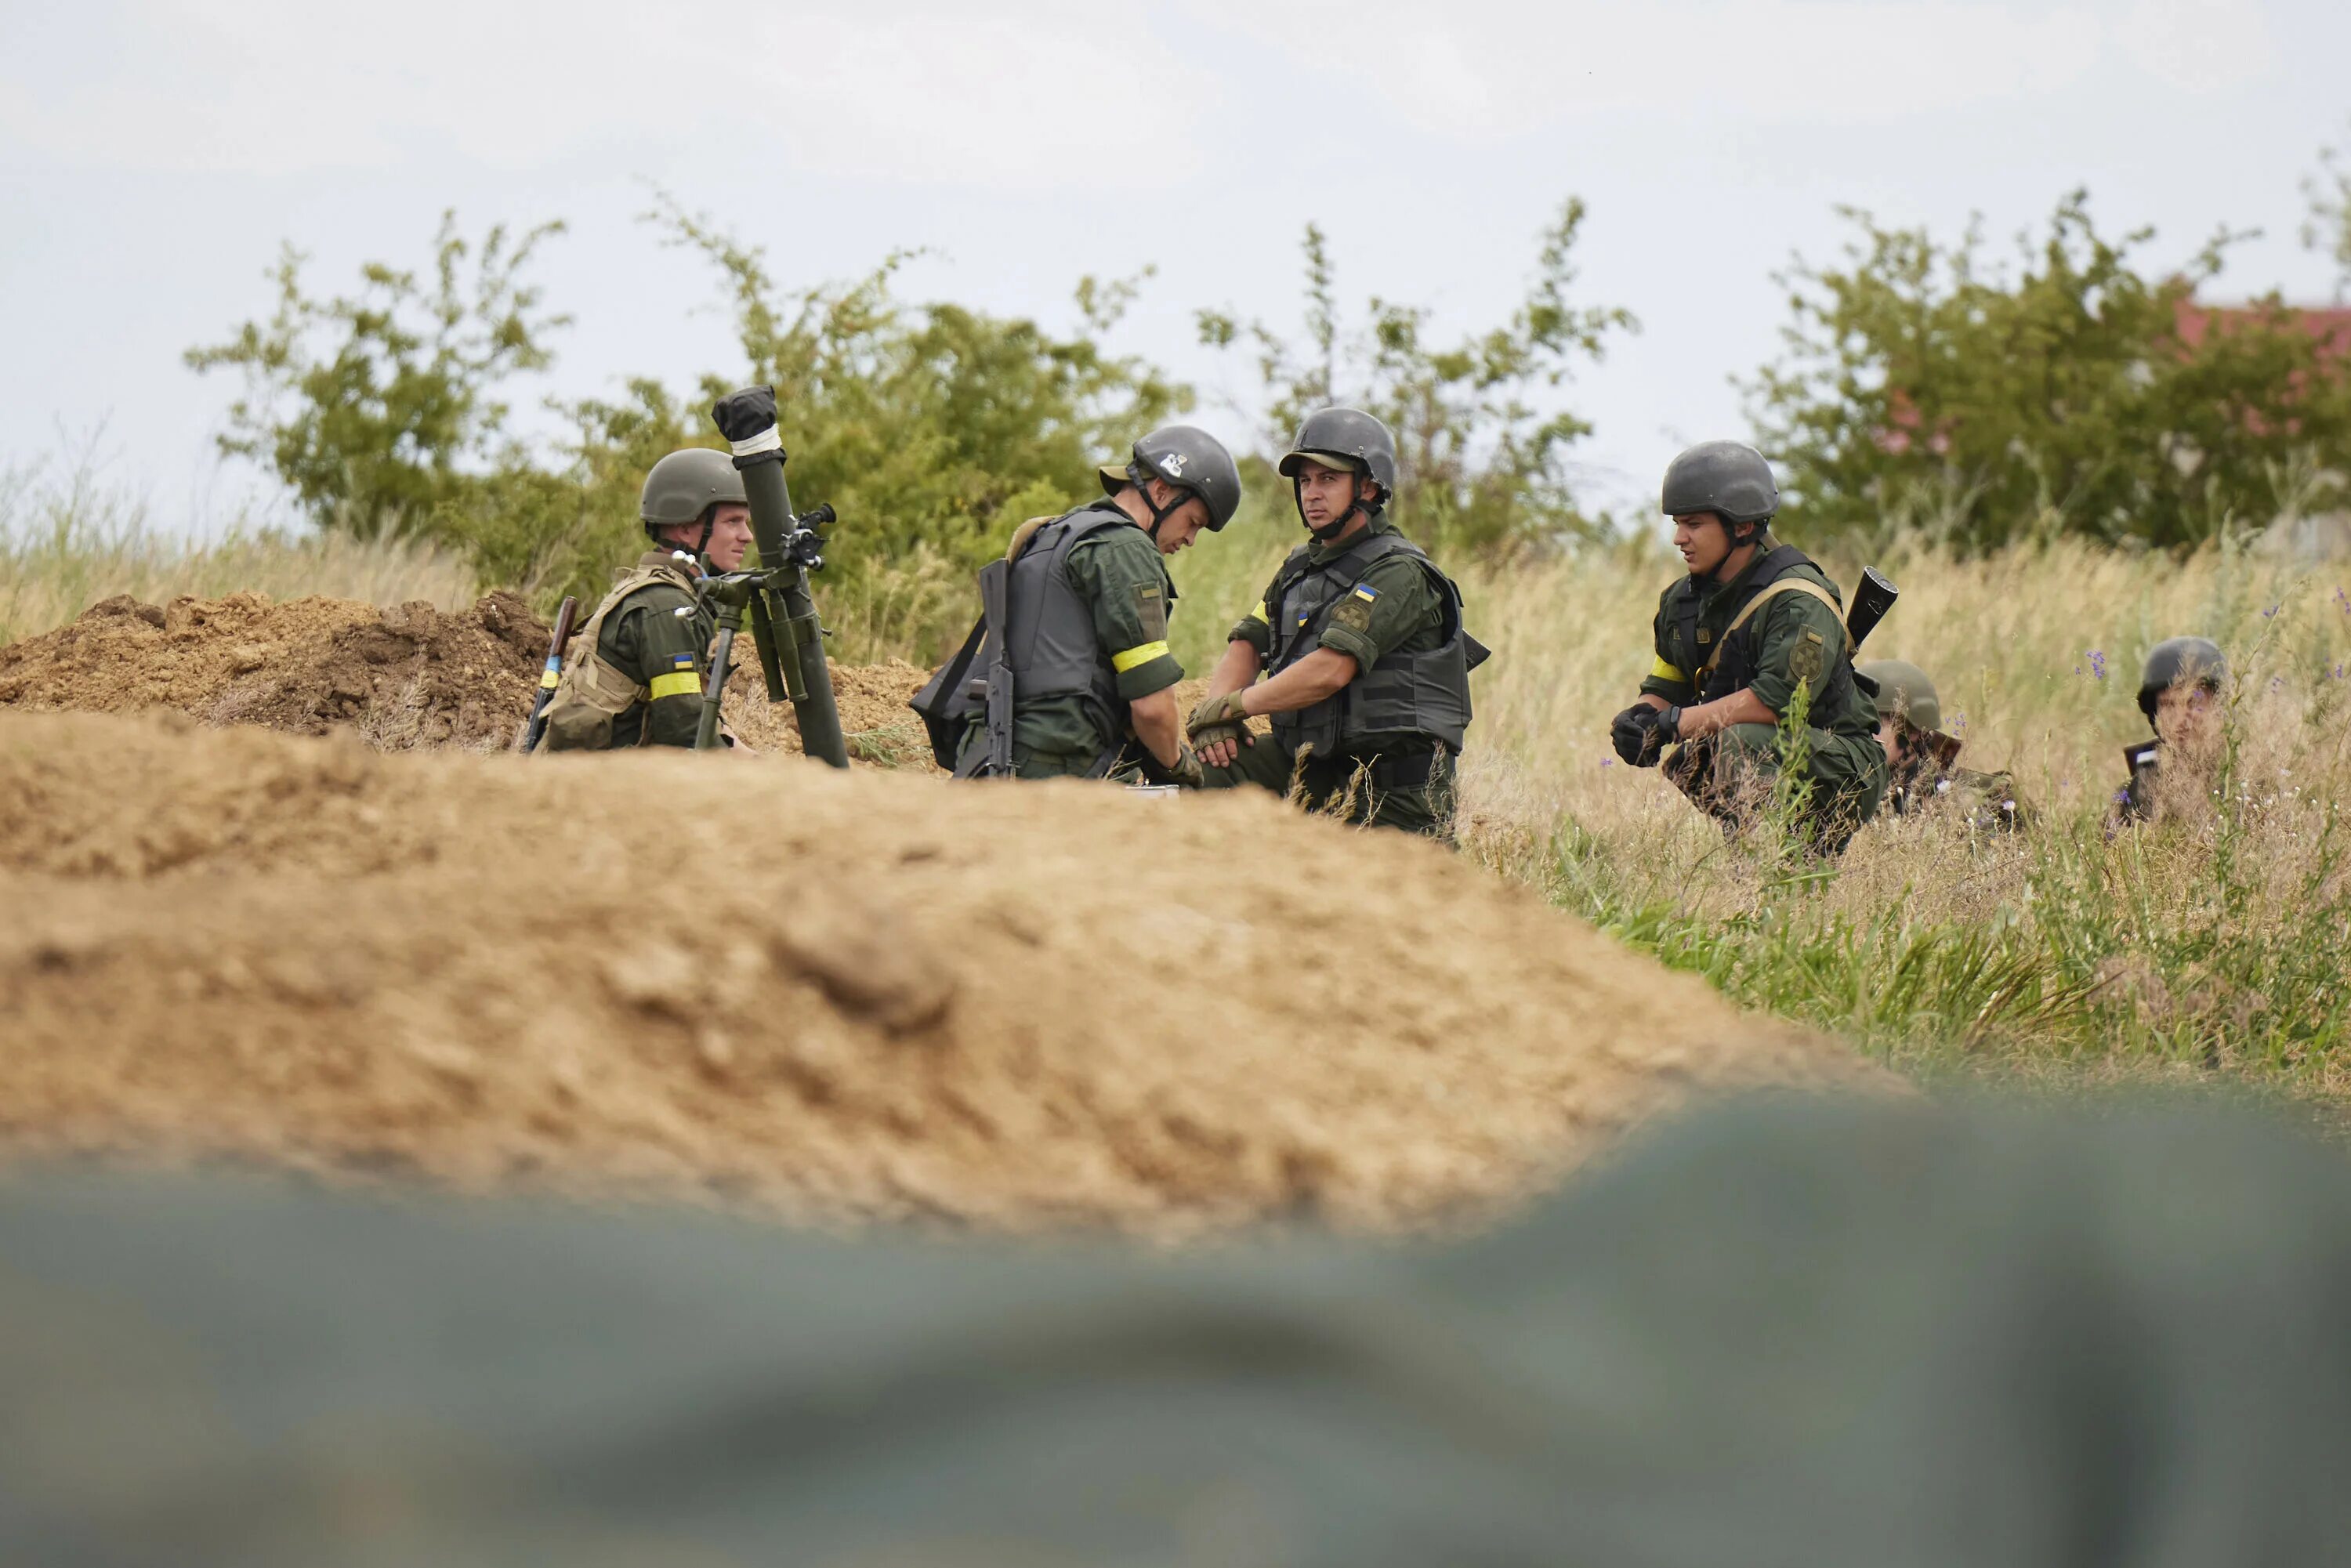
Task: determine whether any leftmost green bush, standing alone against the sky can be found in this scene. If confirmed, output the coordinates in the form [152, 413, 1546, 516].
[186, 212, 569, 538]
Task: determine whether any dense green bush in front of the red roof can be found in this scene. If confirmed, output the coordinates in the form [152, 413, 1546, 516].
[1744, 193, 2351, 548]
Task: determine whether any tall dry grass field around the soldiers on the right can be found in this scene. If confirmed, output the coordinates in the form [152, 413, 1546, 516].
[1462, 534, 2351, 1095]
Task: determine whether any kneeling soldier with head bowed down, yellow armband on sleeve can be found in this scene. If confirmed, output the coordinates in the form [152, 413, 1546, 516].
[912, 425, 1241, 783]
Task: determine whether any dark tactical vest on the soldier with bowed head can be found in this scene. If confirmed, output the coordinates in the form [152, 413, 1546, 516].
[910, 503, 1136, 771]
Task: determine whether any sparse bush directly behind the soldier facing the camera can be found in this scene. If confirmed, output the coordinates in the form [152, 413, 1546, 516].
[1199, 200, 1639, 552]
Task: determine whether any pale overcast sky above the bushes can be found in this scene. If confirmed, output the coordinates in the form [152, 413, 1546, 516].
[0, 0, 2351, 527]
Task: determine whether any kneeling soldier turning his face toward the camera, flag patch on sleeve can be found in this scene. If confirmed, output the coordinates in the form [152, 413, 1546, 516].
[1190, 409, 1486, 842]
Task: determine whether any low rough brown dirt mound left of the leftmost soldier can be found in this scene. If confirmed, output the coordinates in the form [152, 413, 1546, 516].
[0, 592, 548, 750]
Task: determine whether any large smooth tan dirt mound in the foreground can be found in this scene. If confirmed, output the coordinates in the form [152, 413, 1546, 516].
[0, 712, 1867, 1229]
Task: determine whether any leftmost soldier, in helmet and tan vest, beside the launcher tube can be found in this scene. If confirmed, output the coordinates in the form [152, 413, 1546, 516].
[538, 447, 750, 752]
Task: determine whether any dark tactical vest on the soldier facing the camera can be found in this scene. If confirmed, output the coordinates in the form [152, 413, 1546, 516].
[1265, 534, 1486, 757]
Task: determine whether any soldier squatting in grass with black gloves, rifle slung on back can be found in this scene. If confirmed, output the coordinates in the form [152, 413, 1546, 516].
[1608, 442, 1886, 853]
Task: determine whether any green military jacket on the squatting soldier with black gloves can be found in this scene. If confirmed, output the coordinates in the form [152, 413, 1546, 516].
[1641, 536, 1878, 736]
